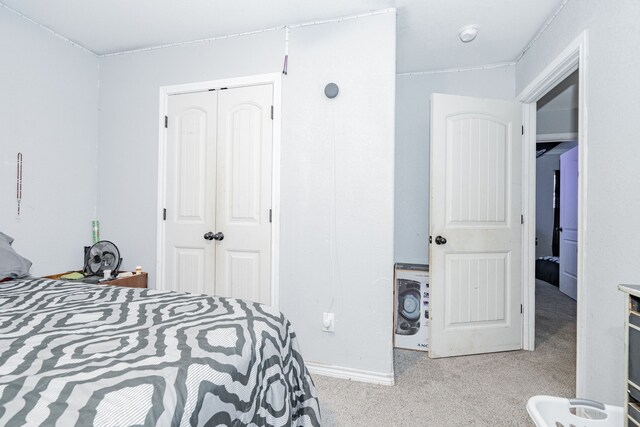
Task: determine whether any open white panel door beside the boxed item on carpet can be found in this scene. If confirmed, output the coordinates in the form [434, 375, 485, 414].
[429, 94, 522, 357]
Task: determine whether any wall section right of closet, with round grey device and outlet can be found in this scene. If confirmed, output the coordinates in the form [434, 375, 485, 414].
[281, 13, 395, 373]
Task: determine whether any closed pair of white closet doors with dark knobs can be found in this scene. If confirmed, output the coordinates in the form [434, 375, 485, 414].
[163, 84, 273, 304]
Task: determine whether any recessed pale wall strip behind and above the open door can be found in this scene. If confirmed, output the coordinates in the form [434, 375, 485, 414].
[395, 66, 515, 264]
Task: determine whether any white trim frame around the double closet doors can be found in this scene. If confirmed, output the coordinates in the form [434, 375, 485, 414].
[156, 73, 282, 309]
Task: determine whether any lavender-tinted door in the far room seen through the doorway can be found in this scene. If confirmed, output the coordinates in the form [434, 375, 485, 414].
[560, 147, 578, 299]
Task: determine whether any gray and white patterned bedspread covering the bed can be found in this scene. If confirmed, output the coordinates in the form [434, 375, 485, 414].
[0, 279, 320, 427]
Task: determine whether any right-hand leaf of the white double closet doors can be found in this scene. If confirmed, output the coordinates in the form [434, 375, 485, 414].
[216, 85, 273, 304]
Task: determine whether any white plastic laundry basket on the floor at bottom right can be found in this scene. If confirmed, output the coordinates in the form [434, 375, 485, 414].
[527, 396, 624, 427]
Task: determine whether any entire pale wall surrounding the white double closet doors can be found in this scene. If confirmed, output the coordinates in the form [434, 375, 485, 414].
[98, 13, 395, 374]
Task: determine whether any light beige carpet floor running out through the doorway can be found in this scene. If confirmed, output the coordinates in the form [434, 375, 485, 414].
[313, 281, 576, 426]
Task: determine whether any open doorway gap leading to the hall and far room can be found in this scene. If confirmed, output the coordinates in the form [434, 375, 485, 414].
[532, 71, 579, 396]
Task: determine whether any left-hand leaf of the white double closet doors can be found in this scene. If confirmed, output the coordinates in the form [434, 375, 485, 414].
[164, 91, 218, 294]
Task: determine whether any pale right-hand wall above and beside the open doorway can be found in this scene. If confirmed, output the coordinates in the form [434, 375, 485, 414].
[516, 0, 640, 405]
